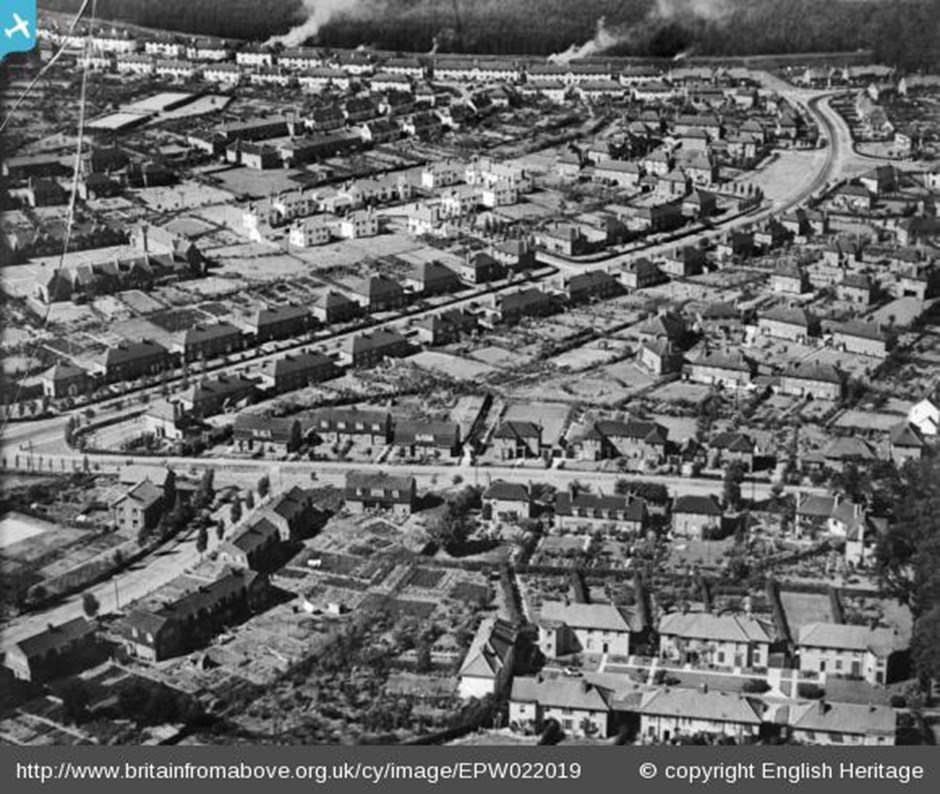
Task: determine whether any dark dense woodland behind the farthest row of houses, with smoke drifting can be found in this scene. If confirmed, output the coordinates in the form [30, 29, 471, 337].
[41, 0, 940, 70]
